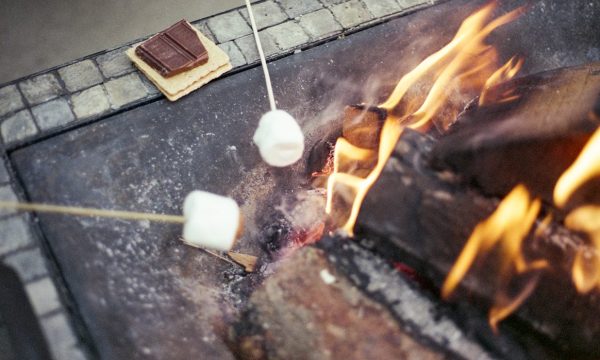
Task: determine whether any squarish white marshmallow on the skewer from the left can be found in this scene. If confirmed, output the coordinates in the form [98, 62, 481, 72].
[183, 190, 241, 251]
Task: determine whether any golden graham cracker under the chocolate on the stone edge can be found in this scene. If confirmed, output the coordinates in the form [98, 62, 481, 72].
[126, 26, 233, 101]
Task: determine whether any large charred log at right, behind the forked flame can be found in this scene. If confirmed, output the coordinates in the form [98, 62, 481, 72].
[433, 63, 600, 208]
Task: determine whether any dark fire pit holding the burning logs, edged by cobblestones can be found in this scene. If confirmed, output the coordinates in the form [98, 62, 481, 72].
[1, 0, 600, 359]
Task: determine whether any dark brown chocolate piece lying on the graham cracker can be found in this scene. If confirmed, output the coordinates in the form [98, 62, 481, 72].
[135, 20, 208, 78]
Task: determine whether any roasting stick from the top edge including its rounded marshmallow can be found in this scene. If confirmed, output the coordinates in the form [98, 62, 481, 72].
[246, 0, 304, 167]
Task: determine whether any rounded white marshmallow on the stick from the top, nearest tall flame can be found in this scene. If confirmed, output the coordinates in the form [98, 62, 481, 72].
[253, 110, 304, 167]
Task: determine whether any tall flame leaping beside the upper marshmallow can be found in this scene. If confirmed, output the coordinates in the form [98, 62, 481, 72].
[326, 3, 521, 235]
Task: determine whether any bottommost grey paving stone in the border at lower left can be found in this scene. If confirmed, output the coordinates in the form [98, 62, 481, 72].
[42, 312, 77, 360]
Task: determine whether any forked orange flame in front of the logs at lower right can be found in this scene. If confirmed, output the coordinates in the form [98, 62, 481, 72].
[442, 185, 548, 328]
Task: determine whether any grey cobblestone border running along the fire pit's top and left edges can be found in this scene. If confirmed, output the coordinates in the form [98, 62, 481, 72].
[0, 0, 435, 359]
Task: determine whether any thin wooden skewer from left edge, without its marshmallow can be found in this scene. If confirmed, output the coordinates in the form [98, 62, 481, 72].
[0, 201, 185, 224]
